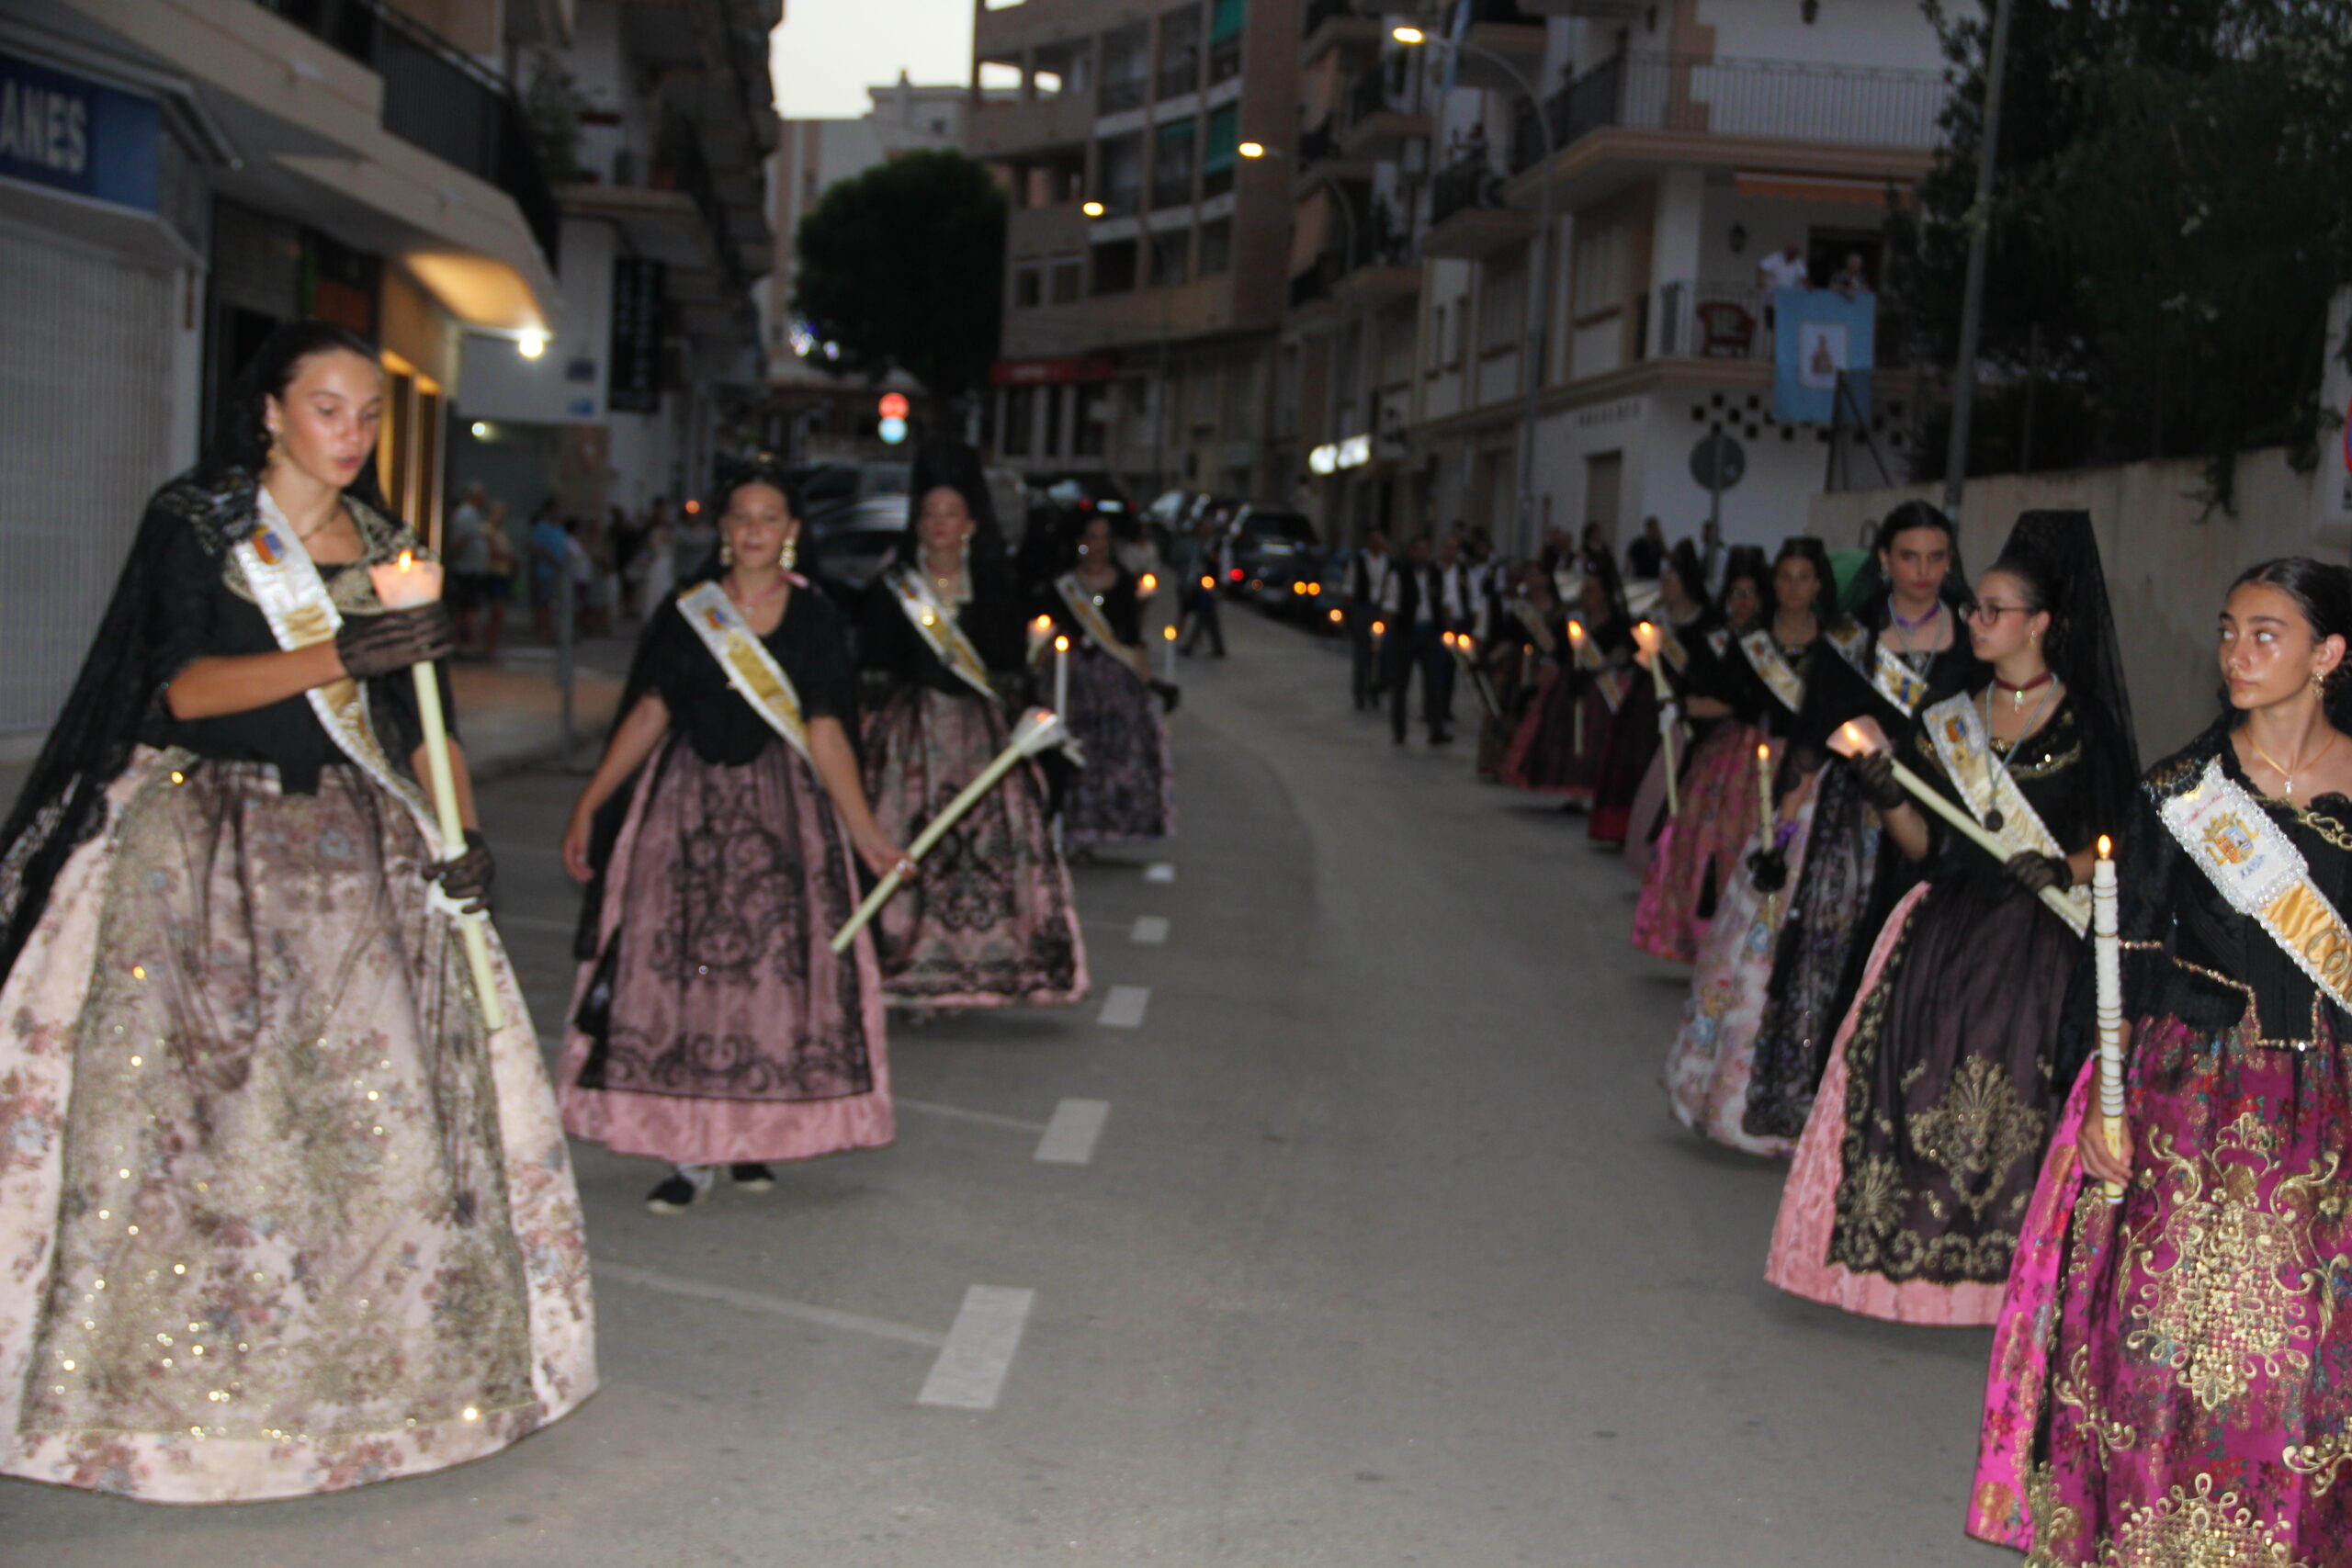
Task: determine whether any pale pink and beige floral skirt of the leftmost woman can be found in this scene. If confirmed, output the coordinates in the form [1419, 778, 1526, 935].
[0, 750, 595, 1502]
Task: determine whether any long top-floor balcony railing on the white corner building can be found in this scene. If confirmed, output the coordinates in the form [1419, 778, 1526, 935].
[1510, 54, 1952, 174]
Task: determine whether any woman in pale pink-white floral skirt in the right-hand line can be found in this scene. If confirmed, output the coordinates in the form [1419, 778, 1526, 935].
[1665, 538, 1837, 1155]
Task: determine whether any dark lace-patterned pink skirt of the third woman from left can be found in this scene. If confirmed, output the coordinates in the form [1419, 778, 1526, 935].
[865, 684, 1087, 1006]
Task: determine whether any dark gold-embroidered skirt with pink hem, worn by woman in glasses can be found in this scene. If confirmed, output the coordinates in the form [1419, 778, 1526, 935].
[1764, 882, 2082, 1325]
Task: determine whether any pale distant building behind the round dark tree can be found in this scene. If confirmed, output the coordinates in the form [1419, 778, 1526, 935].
[760, 73, 988, 461]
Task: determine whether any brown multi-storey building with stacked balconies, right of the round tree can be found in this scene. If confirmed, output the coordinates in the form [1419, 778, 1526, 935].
[967, 0, 1303, 499]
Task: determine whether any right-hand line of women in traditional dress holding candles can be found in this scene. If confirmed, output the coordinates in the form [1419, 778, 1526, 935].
[1350, 503, 2352, 1568]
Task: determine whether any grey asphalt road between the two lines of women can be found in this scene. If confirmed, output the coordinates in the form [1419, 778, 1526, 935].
[0, 614, 2013, 1568]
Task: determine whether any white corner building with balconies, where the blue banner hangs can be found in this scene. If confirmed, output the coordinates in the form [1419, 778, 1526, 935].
[1277, 0, 1950, 561]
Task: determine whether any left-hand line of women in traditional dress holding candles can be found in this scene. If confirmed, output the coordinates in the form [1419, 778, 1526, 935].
[0, 322, 1173, 1502]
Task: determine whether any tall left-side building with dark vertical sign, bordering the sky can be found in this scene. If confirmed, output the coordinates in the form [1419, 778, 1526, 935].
[449, 0, 783, 517]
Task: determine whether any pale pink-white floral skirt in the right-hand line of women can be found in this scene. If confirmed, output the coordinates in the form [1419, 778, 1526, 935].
[1665, 792, 1814, 1155]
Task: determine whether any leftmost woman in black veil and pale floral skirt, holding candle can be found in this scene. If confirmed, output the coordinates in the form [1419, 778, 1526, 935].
[0, 322, 595, 1502]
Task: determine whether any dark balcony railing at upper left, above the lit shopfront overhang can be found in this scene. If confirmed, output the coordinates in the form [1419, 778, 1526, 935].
[256, 0, 562, 268]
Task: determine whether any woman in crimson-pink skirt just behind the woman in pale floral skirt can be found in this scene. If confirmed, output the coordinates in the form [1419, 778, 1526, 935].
[1628, 541, 1771, 964]
